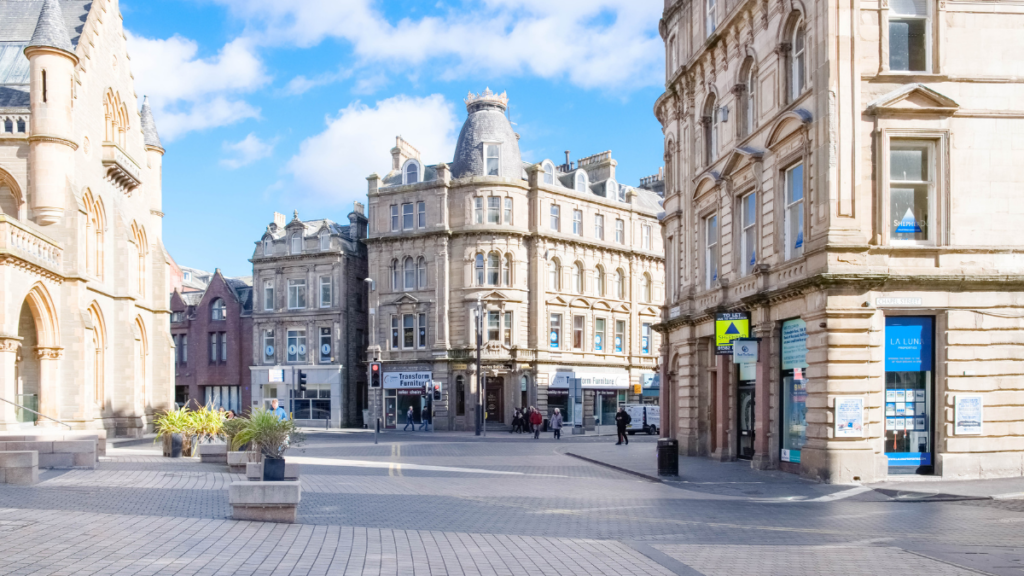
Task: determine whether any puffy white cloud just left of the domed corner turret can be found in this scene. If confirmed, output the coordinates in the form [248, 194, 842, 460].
[287, 94, 461, 203]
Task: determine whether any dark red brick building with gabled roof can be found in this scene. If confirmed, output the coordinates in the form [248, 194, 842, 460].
[171, 269, 253, 413]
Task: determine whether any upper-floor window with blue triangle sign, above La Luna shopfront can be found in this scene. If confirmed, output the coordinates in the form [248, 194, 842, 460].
[889, 138, 936, 245]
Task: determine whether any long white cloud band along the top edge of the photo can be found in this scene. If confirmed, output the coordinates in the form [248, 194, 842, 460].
[216, 0, 664, 90]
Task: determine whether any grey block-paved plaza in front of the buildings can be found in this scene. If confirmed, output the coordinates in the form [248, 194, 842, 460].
[0, 431, 1024, 576]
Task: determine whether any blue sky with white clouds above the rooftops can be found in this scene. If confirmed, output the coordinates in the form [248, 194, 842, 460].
[121, 0, 664, 276]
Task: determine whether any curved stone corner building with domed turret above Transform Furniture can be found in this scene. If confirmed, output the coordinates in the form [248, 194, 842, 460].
[367, 90, 664, 429]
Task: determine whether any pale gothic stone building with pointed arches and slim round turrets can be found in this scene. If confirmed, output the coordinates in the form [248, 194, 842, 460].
[0, 0, 173, 437]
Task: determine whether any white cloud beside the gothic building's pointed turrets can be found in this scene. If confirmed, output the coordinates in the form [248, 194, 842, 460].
[128, 33, 269, 141]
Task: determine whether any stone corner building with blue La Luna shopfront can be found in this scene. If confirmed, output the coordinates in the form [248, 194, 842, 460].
[655, 0, 1024, 482]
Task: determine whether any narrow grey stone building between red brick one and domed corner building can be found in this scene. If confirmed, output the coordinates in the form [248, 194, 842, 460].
[249, 207, 368, 427]
